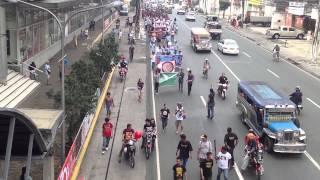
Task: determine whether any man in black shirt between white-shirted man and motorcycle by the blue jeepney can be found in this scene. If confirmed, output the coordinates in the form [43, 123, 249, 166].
[224, 127, 239, 167]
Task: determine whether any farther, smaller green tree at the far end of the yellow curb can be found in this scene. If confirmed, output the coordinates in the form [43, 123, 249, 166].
[89, 34, 119, 77]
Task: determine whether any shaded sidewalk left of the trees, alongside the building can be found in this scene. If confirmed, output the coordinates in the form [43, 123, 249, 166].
[18, 12, 112, 109]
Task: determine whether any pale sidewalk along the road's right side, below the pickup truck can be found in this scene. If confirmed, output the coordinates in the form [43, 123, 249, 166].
[224, 22, 320, 78]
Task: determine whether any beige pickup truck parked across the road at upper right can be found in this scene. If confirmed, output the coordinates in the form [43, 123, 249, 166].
[266, 26, 304, 39]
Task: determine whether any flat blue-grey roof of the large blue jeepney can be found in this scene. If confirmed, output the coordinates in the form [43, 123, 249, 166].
[239, 81, 295, 107]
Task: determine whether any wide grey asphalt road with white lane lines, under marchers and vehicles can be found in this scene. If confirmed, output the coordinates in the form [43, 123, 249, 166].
[155, 11, 320, 180]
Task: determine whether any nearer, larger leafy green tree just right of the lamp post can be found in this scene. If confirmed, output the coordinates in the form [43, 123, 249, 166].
[65, 60, 100, 141]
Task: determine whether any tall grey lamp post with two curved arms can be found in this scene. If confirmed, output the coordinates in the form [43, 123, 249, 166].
[8, 0, 123, 163]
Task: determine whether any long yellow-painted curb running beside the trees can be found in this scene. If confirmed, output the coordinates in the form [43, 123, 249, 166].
[71, 68, 115, 180]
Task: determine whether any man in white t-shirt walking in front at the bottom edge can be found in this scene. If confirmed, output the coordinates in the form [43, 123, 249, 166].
[216, 146, 231, 180]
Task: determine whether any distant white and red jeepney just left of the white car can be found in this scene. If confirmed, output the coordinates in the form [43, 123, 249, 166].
[190, 28, 212, 52]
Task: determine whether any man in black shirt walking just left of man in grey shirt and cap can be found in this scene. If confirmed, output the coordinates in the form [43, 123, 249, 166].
[176, 134, 193, 167]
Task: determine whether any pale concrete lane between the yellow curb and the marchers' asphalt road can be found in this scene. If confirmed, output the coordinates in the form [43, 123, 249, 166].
[78, 18, 150, 180]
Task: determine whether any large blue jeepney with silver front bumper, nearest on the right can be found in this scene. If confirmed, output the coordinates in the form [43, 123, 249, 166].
[236, 81, 306, 153]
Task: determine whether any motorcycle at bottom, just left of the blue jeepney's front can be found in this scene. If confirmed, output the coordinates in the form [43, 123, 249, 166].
[241, 146, 264, 180]
